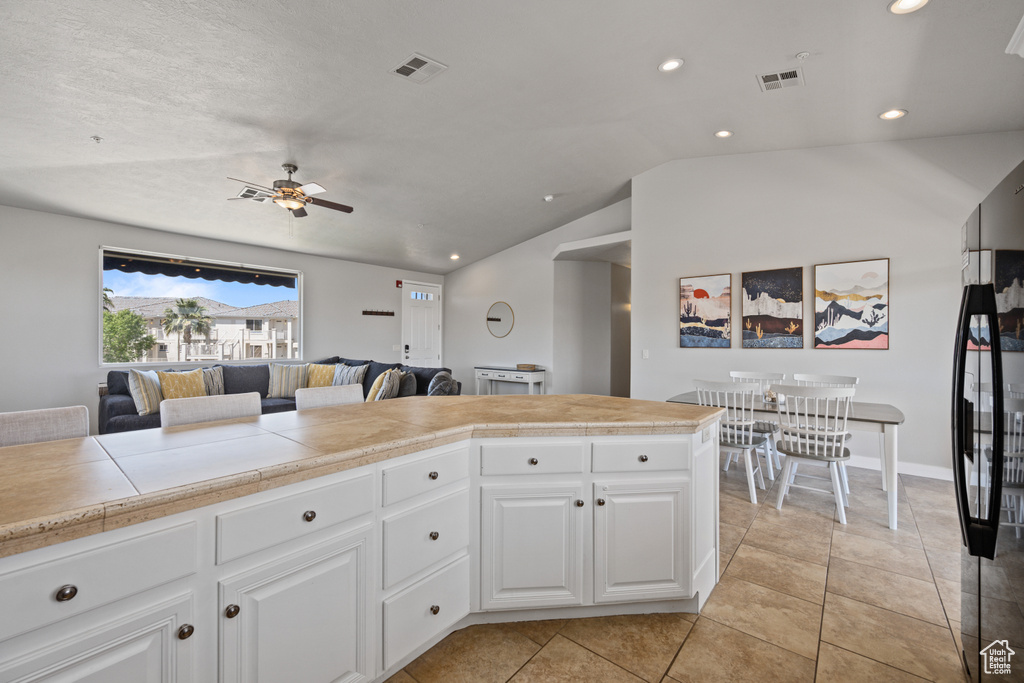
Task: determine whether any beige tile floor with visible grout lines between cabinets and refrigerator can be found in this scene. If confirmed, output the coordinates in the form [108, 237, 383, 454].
[389, 454, 964, 683]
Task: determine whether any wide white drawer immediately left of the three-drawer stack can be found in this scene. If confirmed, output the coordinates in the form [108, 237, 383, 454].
[217, 473, 374, 564]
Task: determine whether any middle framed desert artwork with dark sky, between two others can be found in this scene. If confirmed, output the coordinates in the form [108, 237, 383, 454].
[742, 267, 804, 348]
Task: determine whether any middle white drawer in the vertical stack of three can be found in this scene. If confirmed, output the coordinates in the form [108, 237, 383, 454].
[383, 488, 469, 589]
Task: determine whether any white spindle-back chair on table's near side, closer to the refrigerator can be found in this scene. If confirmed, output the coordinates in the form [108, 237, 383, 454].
[774, 384, 856, 524]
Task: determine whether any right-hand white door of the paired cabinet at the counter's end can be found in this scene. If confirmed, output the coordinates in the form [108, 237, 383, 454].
[594, 479, 691, 603]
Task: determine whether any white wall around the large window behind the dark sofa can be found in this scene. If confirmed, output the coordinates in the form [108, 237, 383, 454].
[0, 206, 443, 432]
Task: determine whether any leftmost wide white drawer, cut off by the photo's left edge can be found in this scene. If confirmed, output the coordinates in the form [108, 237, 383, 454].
[0, 522, 196, 641]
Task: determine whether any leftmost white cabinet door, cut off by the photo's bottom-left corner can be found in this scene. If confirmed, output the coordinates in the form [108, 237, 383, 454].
[0, 594, 197, 683]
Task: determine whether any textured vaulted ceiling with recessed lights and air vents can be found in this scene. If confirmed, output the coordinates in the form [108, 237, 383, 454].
[0, 0, 1024, 273]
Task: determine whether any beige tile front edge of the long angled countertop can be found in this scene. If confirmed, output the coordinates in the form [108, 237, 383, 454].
[0, 395, 722, 557]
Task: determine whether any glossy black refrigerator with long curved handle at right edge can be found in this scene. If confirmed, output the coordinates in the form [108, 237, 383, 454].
[952, 157, 1024, 681]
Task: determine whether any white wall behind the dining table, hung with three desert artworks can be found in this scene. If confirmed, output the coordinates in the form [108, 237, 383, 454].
[631, 131, 1024, 474]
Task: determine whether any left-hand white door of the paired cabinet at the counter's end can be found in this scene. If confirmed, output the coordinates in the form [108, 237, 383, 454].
[480, 482, 590, 609]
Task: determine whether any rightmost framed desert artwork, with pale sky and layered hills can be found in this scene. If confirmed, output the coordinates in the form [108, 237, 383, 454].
[814, 258, 889, 349]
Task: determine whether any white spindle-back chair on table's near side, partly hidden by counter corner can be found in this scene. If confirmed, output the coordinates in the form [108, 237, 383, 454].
[693, 380, 765, 505]
